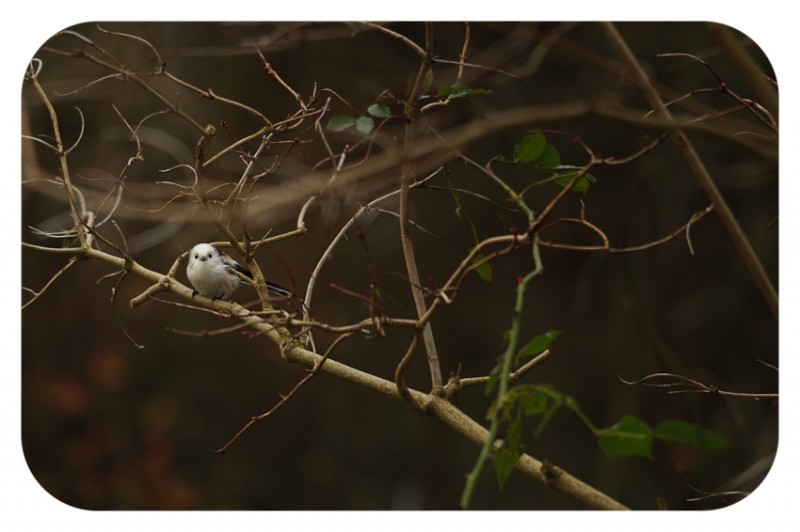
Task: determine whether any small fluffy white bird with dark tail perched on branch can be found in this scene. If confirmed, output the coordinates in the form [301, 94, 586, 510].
[186, 244, 292, 299]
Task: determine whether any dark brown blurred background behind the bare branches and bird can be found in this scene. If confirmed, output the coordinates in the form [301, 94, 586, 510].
[21, 22, 778, 510]
